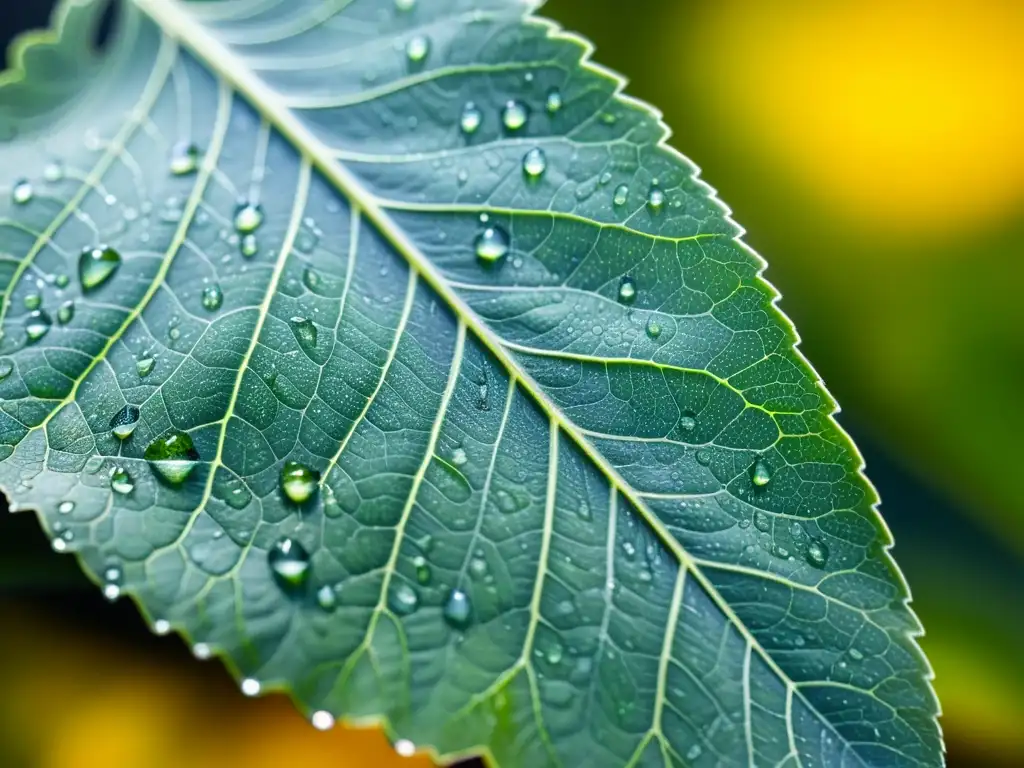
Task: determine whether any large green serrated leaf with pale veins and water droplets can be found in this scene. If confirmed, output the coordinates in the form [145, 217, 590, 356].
[0, 0, 942, 768]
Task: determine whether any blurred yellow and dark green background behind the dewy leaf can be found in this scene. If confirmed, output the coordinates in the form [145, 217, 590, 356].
[0, 0, 1024, 768]
